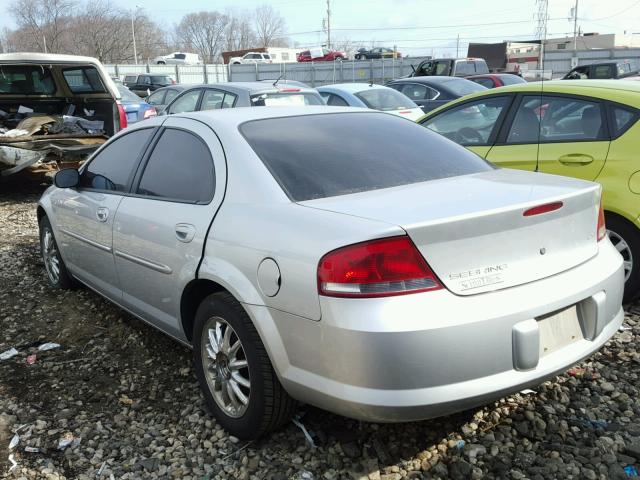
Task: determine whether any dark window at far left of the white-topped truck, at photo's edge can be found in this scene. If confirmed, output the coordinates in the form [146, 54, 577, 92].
[0, 65, 56, 95]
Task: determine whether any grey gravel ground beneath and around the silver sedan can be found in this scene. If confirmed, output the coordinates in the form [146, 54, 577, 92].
[0, 181, 640, 480]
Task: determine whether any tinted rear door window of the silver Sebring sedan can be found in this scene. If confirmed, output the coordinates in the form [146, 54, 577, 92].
[136, 128, 216, 203]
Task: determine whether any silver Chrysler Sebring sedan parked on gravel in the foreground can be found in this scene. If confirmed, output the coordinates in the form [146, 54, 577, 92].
[37, 107, 624, 439]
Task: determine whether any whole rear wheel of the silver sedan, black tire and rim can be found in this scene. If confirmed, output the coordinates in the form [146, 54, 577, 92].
[193, 292, 296, 440]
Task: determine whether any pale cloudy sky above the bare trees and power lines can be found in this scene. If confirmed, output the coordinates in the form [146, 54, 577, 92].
[0, 0, 640, 56]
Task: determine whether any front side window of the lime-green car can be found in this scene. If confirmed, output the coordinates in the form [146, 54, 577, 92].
[422, 97, 510, 146]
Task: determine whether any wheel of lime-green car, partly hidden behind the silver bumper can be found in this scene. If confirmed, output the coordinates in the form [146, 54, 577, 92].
[605, 214, 640, 303]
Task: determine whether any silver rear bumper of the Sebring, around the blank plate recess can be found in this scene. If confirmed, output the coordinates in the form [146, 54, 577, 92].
[247, 240, 624, 422]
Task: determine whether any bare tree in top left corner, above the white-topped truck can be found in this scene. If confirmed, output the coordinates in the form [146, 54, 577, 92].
[10, 0, 76, 52]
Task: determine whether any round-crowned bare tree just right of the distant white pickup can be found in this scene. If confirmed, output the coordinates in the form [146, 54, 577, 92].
[176, 11, 229, 63]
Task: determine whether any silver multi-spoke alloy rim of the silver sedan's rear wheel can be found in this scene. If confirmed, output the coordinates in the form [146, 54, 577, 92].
[201, 317, 251, 418]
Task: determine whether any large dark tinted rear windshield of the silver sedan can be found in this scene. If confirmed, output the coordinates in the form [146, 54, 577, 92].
[240, 112, 495, 202]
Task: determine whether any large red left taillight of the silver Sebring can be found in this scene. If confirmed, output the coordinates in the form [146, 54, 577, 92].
[318, 236, 442, 298]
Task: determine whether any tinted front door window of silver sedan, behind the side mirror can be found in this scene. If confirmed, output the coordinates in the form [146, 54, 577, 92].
[79, 128, 153, 192]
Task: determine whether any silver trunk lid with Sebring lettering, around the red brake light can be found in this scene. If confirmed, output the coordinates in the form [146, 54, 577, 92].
[300, 169, 600, 295]
